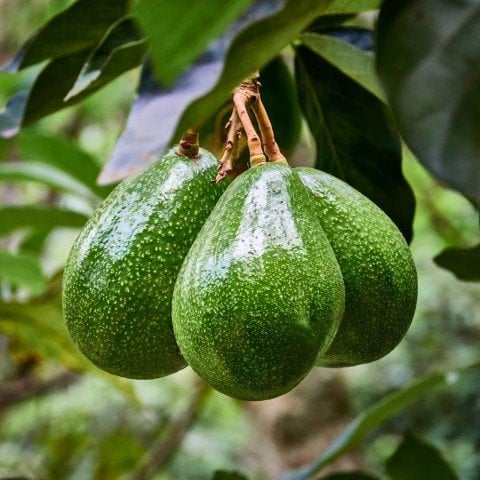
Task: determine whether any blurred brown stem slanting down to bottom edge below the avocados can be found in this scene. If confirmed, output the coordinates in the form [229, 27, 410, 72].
[124, 382, 210, 480]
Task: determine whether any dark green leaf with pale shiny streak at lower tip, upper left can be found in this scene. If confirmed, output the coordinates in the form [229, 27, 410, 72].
[65, 18, 147, 101]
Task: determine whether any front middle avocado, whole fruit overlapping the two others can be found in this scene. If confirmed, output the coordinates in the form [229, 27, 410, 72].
[172, 164, 344, 400]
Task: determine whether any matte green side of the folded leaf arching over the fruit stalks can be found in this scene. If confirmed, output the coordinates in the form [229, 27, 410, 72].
[173, 0, 336, 144]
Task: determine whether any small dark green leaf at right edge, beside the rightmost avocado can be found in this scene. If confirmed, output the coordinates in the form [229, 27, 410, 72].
[434, 244, 480, 282]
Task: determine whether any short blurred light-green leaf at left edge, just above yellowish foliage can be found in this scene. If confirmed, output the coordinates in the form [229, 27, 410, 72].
[0, 249, 47, 295]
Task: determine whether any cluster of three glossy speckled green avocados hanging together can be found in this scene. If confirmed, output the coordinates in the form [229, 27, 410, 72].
[63, 150, 417, 400]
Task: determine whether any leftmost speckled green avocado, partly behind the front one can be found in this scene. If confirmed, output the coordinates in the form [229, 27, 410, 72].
[63, 149, 225, 379]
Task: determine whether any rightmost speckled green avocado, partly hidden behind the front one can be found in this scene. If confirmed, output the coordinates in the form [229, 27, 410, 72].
[295, 168, 417, 367]
